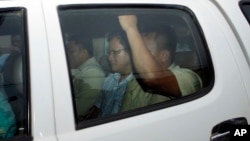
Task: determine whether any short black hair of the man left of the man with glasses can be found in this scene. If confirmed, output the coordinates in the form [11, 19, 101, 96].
[68, 34, 93, 56]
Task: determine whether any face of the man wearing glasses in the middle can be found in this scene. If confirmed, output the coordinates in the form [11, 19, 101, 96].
[109, 37, 132, 74]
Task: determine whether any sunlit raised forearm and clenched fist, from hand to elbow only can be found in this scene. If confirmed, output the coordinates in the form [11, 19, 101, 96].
[119, 15, 162, 79]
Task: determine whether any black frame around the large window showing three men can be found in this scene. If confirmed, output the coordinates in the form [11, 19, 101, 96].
[57, 4, 215, 130]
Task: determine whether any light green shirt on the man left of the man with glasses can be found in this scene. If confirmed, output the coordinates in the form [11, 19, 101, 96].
[72, 57, 105, 117]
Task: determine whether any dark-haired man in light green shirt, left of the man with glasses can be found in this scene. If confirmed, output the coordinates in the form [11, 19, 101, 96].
[67, 36, 105, 121]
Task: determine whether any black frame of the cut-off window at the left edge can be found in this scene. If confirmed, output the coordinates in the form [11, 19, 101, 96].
[0, 7, 33, 141]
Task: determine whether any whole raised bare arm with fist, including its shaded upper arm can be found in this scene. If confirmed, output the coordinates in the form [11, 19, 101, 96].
[118, 15, 181, 97]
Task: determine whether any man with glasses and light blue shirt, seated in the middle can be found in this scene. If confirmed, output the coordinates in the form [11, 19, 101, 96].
[96, 31, 169, 117]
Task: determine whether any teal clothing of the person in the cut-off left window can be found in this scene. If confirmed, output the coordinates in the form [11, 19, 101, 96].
[0, 89, 16, 140]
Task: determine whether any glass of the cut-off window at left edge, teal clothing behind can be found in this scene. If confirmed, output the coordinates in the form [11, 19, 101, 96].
[0, 8, 28, 140]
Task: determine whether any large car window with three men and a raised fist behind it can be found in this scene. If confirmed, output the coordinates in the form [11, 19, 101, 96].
[58, 5, 214, 129]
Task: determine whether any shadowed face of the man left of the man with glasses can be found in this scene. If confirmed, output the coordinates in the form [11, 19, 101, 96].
[67, 42, 86, 69]
